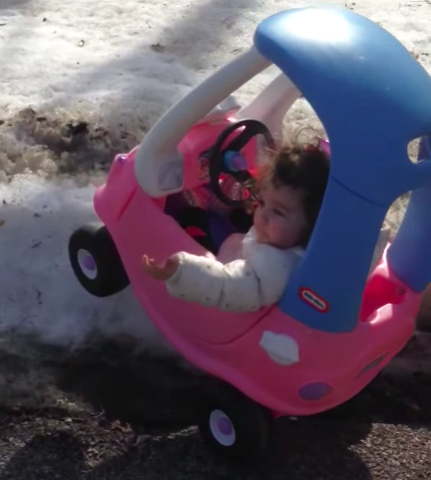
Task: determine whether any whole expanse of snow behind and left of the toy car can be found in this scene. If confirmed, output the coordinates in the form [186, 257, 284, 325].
[0, 0, 431, 354]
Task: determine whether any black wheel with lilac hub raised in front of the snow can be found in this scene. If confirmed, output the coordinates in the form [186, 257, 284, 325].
[69, 224, 130, 297]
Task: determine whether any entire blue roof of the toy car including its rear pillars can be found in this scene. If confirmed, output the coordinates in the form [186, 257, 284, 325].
[254, 7, 431, 333]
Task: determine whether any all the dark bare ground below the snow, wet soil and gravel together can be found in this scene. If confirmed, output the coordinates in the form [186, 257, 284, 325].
[0, 345, 431, 480]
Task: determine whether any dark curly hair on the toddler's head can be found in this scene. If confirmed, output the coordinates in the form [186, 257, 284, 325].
[260, 144, 329, 246]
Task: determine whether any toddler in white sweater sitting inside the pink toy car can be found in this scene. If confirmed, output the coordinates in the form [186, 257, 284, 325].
[143, 145, 329, 312]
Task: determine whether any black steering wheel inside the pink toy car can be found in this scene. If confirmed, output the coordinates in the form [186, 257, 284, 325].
[206, 119, 275, 208]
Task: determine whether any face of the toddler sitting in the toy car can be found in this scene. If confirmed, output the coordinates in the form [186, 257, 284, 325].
[253, 185, 307, 249]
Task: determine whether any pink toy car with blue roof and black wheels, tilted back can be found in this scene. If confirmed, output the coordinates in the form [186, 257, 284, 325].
[69, 8, 431, 458]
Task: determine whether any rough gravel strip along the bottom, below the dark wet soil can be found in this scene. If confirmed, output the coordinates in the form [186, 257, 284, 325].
[0, 413, 431, 480]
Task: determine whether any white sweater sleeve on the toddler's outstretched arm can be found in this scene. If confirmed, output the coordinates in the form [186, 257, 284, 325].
[166, 245, 304, 312]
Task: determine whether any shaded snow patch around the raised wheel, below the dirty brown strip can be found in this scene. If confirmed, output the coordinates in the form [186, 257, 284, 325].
[0, 176, 174, 351]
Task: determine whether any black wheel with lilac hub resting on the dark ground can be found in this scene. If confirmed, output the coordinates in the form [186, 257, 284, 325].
[199, 385, 273, 462]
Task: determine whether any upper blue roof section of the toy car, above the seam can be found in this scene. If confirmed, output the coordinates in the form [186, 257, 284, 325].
[254, 7, 431, 204]
